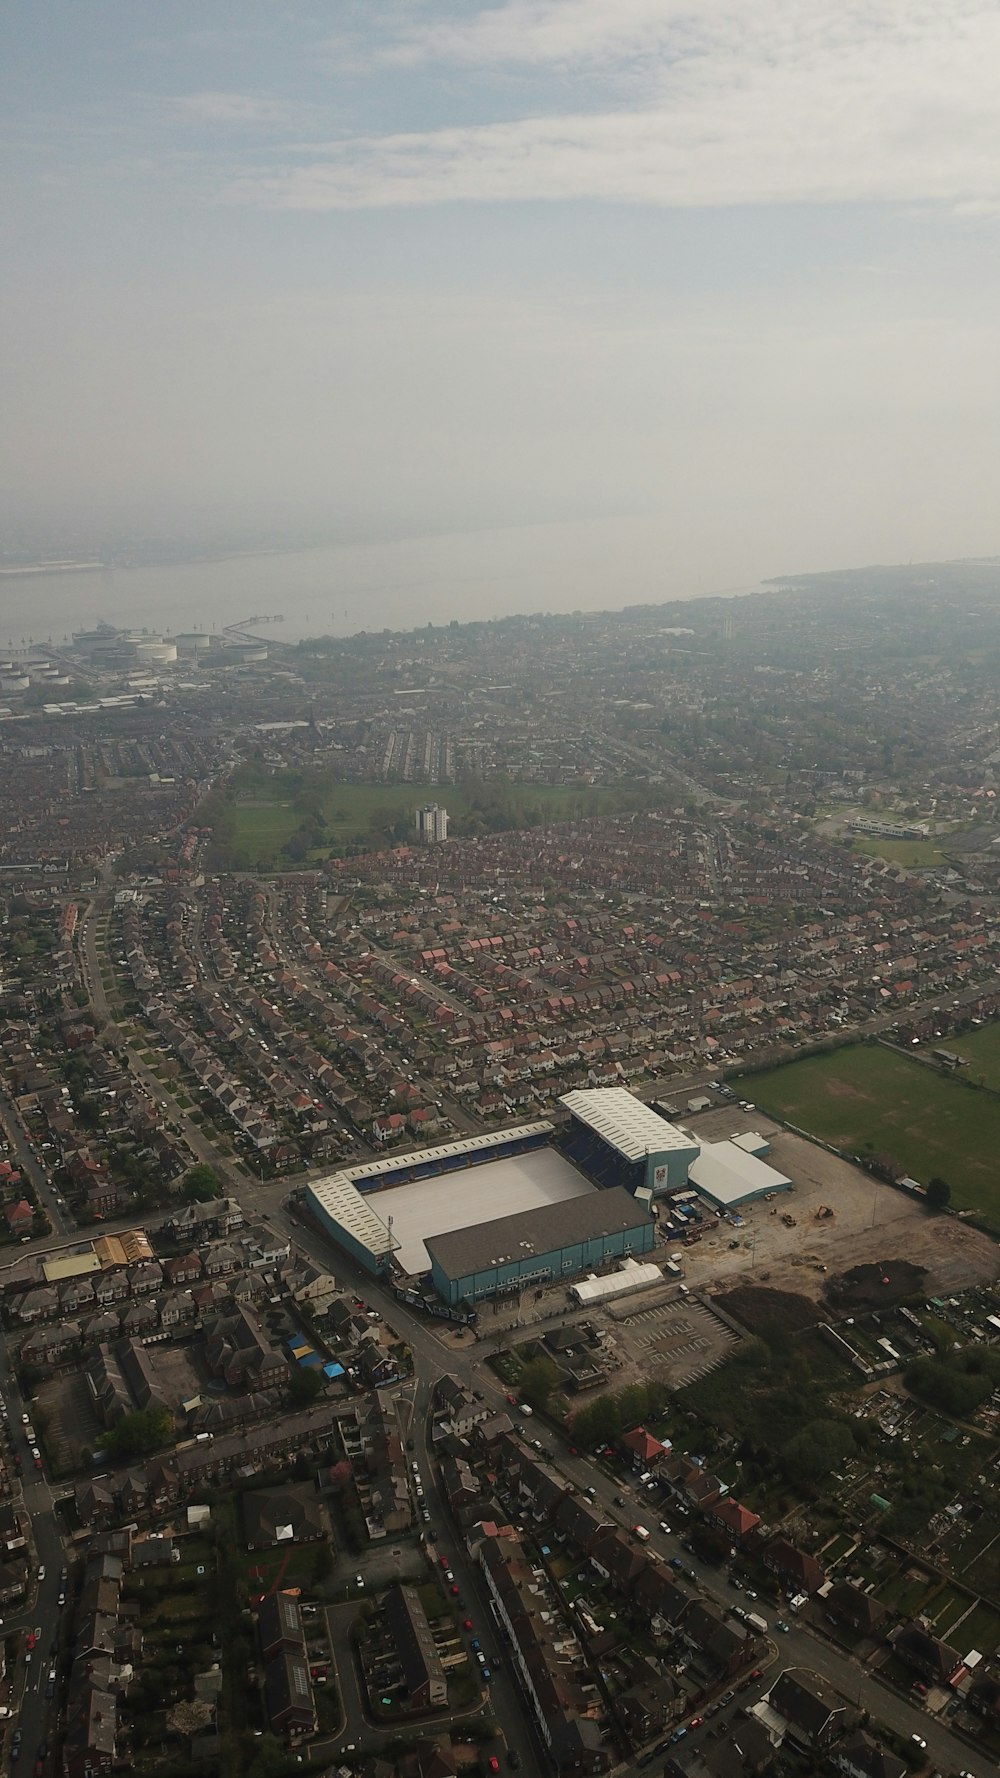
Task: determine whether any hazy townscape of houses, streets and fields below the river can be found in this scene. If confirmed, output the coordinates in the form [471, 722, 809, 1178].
[0, 562, 1000, 1778]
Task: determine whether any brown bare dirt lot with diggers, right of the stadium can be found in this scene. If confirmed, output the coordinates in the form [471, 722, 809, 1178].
[658, 1109, 1000, 1298]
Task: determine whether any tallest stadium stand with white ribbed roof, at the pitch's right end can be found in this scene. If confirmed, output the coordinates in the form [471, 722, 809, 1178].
[559, 1086, 699, 1195]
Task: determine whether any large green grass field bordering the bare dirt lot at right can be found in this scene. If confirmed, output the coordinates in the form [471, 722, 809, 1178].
[746, 1044, 1000, 1220]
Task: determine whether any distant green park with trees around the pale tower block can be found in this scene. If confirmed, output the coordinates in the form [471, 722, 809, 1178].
[226, 784, 635, 868]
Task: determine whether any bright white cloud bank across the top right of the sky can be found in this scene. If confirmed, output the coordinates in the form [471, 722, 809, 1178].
[233, 0, 1000, 210]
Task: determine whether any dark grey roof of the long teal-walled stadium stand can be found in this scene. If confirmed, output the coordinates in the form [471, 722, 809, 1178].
[425, 1186, 649, 1278]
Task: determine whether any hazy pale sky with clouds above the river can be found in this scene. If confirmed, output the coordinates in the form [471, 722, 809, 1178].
[0, 0, 1000, 603]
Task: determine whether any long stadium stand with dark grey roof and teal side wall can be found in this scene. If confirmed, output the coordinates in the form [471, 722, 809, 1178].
[425, 1186, 657, 1305]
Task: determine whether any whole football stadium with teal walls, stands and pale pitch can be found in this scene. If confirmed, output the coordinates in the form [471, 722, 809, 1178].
[302, 1086, 792, 1314]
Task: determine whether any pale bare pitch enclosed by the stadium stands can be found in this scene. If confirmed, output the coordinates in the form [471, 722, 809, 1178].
[365, 1149, 594, 1277]
